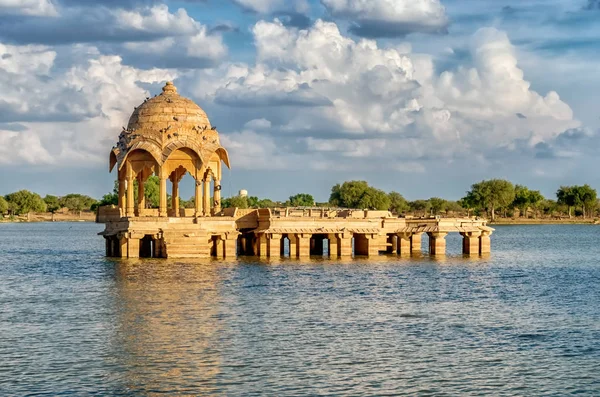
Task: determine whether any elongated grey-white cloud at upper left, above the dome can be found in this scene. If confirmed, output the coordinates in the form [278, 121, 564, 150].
[0, 4, 227, 68]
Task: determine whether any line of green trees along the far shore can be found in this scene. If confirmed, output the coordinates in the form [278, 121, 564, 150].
[0, 176, 600, 220]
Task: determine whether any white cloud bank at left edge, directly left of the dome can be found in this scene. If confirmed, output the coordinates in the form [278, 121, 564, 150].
[0, 44, 175, 166]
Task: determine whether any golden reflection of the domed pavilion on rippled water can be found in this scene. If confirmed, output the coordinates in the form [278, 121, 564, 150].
[113, 260, 221, 395]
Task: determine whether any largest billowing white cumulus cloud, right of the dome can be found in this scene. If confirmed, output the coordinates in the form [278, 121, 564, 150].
[189, 20, 579, 172]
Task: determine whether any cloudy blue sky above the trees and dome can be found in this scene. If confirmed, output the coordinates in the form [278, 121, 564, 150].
[0, 0, 600, 201]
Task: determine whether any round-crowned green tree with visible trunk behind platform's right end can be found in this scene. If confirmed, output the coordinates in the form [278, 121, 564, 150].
[463, 179, 515, 222]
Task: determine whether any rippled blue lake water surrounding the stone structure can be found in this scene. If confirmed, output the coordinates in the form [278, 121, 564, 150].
[0, 223, 600, 396]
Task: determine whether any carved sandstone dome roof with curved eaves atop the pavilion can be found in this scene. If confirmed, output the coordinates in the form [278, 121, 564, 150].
[110, 81, 229, 170]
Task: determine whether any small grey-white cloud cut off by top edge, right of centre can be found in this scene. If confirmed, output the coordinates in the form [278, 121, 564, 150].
[321, 0, 448, 38]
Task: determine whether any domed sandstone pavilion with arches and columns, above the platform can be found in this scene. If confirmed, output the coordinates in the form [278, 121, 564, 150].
[110, 82, 230, 217]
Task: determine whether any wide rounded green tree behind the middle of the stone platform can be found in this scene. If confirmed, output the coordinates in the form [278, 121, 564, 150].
[329, 181, 391, 210]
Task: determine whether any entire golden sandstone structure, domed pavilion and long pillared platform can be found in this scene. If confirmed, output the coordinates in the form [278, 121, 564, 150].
[98, 82, 493, 259]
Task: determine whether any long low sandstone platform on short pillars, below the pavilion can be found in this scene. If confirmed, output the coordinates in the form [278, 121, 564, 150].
[98, 207, 494, 259]
